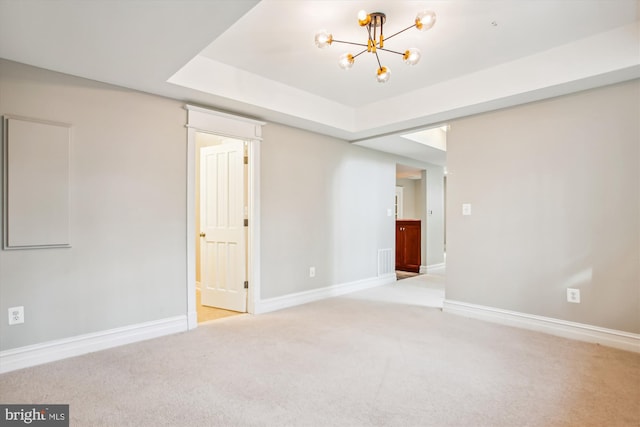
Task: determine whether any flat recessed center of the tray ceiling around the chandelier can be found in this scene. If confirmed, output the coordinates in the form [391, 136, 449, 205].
[202, 0, 635, 107]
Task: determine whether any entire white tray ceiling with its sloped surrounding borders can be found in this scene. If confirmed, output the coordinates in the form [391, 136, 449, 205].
[0, 0, 640, 164]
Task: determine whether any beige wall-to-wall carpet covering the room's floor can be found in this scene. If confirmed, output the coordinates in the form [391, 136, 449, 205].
[0, 279, 640, 427]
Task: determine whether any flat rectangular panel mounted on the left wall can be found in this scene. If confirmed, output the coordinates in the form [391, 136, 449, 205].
[2, 116, 71, 249]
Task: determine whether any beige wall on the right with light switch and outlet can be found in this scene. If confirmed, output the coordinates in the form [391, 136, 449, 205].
[446, 80, 640, 333]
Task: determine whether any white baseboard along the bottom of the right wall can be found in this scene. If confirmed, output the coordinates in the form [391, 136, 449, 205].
[443, 300, 640, 353]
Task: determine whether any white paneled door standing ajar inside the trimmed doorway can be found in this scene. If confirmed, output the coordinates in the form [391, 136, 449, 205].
[200, 140, 247, 312]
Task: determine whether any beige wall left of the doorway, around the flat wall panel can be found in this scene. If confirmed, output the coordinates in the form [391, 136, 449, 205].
[0, 60, 187, 350]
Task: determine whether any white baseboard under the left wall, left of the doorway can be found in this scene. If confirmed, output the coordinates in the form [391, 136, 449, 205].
[0, 316, 187, 373]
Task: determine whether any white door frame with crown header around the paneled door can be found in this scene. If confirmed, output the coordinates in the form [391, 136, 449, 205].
[185, 105, 266, 329]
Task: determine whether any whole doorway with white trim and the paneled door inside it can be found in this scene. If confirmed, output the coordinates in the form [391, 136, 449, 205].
[186, 105, 265, 329]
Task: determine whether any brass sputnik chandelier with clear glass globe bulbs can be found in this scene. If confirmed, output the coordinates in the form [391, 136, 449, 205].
[315, 10, 436, 83]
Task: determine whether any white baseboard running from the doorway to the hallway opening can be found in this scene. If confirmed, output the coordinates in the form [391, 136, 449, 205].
[255, 271, 396, 314]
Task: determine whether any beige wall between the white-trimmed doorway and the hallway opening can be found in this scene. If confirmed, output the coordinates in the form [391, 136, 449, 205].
[260, 124, 396, 298]
